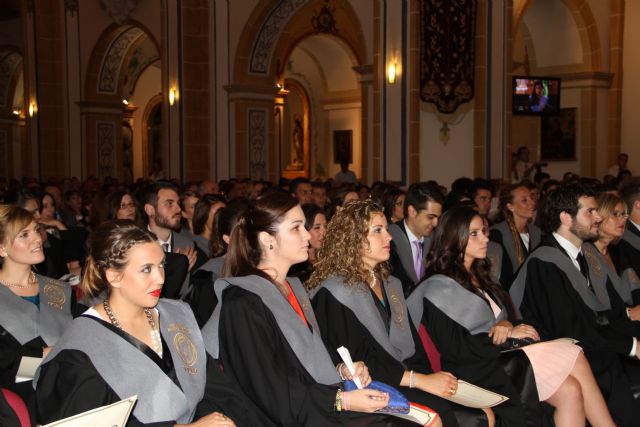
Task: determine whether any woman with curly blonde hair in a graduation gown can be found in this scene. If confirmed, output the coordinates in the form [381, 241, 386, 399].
[307, 200, 493, 426]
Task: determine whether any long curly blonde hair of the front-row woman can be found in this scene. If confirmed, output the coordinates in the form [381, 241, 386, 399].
[305, 200, 389, 289]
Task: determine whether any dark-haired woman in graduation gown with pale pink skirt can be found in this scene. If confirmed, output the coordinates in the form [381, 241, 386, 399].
[408, 207, 614, 427]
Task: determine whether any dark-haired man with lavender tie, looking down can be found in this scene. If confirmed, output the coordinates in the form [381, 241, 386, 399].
[389, 182, 444, 296]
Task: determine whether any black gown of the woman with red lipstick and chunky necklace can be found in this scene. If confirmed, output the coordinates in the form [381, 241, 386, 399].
[35, 322, 268, 427]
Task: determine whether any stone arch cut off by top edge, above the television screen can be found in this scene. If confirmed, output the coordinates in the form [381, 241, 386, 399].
[513, 0, 602, 71]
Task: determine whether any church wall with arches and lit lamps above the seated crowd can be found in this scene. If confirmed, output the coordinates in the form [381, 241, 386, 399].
[0, 0, 640, 186]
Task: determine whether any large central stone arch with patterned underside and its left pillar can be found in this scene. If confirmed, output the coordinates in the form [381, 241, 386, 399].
[228, 0, 369, 181]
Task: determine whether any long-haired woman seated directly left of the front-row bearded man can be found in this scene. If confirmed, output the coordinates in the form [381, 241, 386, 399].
[489, 184, 542, 291]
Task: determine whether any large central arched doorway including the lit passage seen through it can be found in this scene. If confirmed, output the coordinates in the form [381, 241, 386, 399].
[228, 0, 373, 182]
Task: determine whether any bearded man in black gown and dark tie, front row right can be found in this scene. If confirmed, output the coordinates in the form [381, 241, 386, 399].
[510, 184, 640, 426]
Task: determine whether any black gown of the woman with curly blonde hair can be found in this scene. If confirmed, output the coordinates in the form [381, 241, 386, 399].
[312, 288, 487, 427]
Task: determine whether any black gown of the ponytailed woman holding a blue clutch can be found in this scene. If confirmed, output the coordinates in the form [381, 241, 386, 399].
[219, 286, 415, 427]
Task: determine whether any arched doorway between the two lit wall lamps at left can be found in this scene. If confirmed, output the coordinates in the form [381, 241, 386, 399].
[81, 22, 161, 182]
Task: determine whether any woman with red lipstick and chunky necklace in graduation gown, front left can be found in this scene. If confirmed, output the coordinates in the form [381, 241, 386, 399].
[34, 220, 260, 427]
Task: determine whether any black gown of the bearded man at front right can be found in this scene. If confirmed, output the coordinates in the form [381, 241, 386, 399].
[520, 236, 640, 426]
